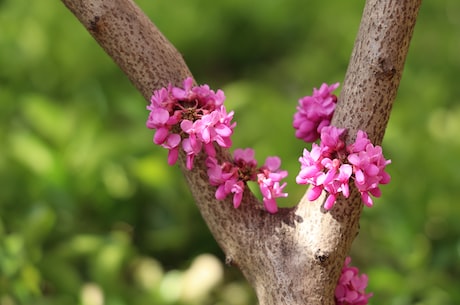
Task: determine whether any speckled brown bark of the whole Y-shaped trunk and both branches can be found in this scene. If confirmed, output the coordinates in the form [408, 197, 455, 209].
[62, 0, 421, 305]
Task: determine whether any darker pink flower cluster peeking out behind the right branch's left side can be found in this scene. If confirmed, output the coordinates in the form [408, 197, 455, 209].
[293, 83, 339, 142]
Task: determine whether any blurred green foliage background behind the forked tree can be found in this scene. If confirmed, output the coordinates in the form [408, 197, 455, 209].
[0, 0, 460, 305]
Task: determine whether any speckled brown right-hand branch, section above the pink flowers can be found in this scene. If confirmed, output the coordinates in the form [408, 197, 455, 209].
[332, 0, 421, 144]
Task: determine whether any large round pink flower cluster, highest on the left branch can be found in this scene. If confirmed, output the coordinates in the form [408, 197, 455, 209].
[146, 77, 236, 169]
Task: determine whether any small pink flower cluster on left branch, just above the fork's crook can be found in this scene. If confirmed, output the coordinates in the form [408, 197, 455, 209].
[206, 148, 287, 214]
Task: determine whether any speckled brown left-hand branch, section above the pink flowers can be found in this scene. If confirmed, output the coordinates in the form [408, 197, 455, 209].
[62, 0, 192, 96]
